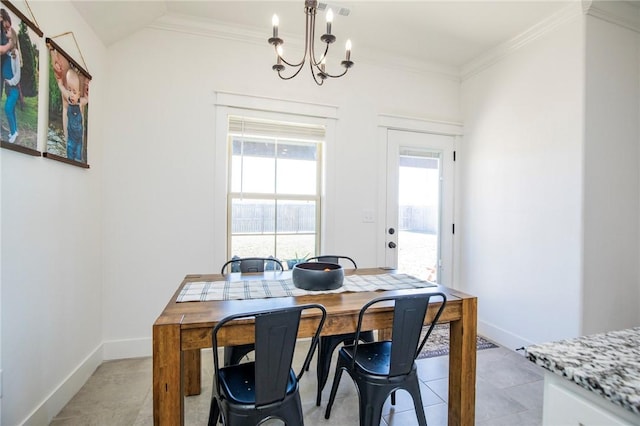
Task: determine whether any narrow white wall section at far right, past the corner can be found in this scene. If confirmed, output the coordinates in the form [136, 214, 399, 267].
[581, 12, 640, 334]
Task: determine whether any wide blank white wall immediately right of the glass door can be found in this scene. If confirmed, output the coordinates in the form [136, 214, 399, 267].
[459, 17, 584, 349]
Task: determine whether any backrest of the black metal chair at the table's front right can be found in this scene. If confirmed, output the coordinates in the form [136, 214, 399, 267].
[352, 292, 447, 377]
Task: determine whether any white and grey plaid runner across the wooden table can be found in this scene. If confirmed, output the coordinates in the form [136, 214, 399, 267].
[177, 274, 436, 302]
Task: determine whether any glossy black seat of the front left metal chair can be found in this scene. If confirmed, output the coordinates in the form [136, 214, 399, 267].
[219, 362, 297, 405]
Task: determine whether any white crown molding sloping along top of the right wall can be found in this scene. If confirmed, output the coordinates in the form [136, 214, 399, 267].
[460, 2, 583, 81]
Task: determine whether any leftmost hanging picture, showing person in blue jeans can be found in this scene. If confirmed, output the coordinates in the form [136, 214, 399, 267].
[0, 0, 43, 156]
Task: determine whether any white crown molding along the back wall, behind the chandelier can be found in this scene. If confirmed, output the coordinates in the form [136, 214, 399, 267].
[146, 14, 460, 82]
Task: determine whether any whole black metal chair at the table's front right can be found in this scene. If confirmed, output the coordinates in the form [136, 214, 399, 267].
[324, 292, 447, 426]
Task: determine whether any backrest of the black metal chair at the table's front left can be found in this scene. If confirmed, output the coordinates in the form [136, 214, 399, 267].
[212, 304, 327, 407]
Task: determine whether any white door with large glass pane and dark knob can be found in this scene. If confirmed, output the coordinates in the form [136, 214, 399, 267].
[385, 130, 455, 285]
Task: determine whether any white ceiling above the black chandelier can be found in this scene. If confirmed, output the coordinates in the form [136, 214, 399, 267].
[72, 0, 579, 67]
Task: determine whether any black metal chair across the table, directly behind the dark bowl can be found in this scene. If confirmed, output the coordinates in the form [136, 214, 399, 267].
[307, 254, 374, 406]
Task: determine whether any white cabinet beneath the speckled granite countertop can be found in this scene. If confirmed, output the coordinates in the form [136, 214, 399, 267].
[542, 372, 640, 426]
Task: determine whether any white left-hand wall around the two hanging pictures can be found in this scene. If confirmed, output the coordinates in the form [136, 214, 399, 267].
[1, 1, 106, 426]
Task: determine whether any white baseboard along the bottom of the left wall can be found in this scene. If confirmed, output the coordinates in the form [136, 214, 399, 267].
[20, 344, 103, 426]
